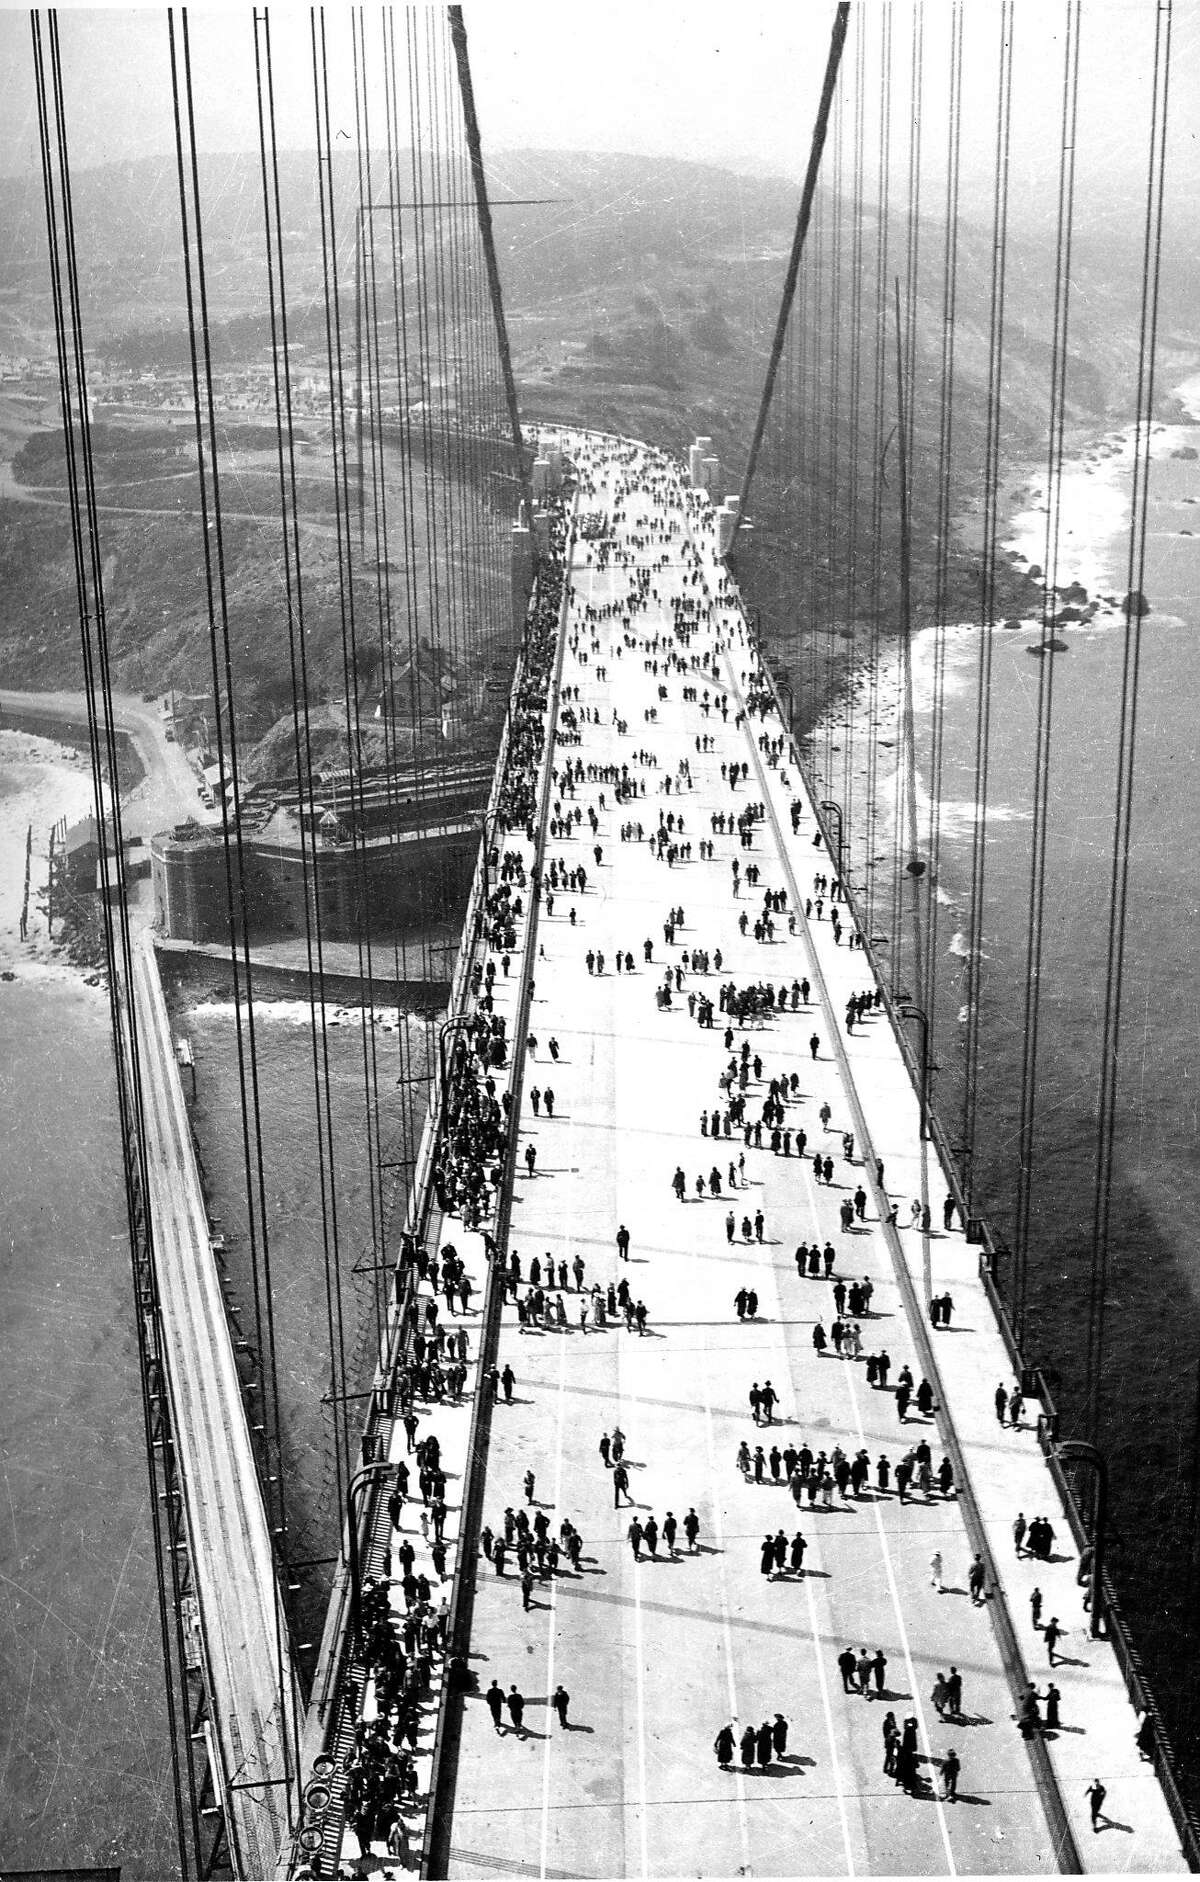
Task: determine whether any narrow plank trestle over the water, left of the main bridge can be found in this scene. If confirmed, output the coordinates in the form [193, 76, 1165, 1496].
[134, 933, 299, 1876]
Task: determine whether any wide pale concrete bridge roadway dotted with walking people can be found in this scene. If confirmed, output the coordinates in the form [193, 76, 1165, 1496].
[338, 430, 1185, 1876]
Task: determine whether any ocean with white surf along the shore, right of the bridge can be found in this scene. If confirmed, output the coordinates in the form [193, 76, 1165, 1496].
[813, 388, 1200, 1760]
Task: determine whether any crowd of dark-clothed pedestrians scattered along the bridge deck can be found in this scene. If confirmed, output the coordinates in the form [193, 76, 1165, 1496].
[327, 436, 1143, 1846]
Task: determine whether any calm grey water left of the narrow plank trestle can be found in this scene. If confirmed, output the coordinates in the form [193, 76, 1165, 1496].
[0, 964, 177, 1878]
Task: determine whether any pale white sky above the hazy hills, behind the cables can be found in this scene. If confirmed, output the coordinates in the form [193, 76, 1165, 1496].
[0, 0, 1200, 230]
